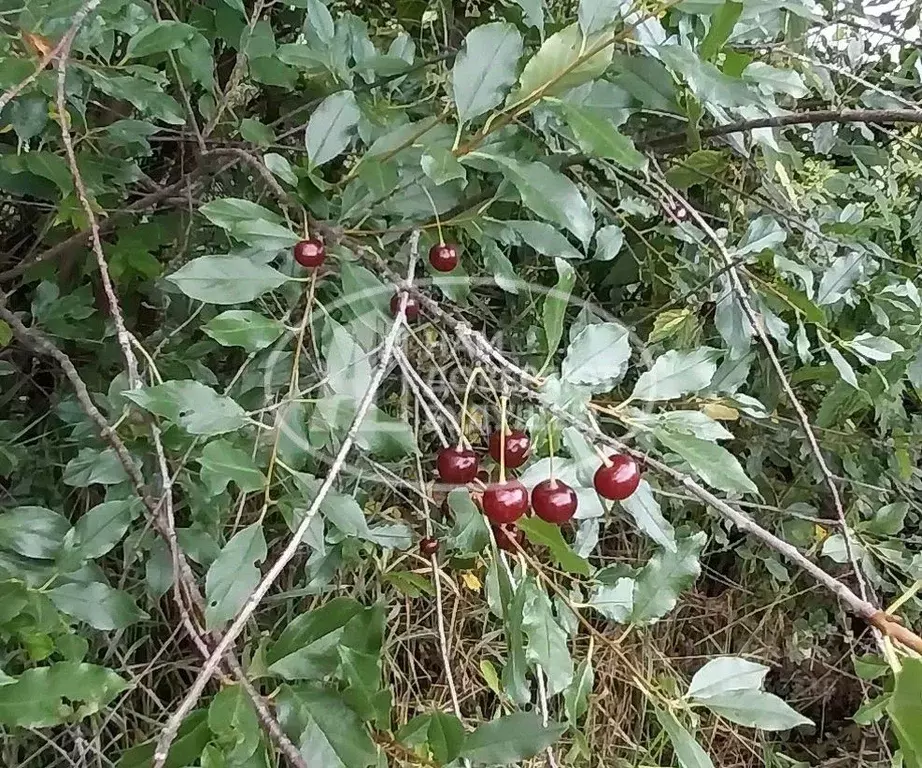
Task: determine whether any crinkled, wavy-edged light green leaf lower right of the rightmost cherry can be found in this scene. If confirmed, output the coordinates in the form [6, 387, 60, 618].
[631, 533, 706, 623]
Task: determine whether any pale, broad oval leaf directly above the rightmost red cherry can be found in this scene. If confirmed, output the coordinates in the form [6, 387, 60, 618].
[560, 322, 631, 392]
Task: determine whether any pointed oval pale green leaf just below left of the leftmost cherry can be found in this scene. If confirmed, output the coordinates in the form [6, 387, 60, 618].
[167, 256, 288, 304]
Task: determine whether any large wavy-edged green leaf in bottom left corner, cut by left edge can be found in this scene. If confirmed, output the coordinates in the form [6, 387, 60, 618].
[0, 661, 128, 728]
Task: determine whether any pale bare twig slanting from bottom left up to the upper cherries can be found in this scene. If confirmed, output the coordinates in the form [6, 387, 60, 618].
[152, 232, 419, 768]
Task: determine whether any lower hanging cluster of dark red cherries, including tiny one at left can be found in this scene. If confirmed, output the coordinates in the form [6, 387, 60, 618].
[420, 430, 640, 555]
